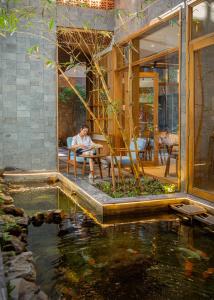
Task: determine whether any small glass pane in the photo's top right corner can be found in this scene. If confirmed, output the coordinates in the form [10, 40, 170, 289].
[192, 0, 214, 39]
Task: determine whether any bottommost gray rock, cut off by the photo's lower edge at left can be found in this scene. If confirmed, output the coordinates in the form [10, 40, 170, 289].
[10, 278, 48, 300]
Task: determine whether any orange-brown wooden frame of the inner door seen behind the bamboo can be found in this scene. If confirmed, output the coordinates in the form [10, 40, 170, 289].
[138, 72, 159, 165]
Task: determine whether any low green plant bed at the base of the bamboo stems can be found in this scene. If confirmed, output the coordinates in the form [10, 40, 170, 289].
[95, 177, 177, 198]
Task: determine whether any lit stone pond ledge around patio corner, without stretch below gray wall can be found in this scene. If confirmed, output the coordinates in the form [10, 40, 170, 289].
[59, 174, 214, 220]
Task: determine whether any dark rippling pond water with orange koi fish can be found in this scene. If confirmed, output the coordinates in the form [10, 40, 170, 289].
[13, 189, 214, 300]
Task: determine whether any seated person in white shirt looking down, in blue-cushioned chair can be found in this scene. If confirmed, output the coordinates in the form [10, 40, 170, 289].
[72, 125, 95, 179]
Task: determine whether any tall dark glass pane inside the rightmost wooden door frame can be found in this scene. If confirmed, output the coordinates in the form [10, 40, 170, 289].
[193, 45, 214, 193]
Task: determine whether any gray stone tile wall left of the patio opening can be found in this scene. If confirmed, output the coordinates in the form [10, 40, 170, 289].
[0, 0, 57, 170]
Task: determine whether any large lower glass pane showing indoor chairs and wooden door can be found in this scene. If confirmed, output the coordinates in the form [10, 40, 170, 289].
[139, 51, 179, 183]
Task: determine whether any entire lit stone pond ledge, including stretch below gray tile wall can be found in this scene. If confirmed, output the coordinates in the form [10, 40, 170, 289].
[4, 172, 214, 221]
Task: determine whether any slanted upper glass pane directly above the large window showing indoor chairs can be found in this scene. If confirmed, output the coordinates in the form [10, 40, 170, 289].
[139, 17, 179, 58]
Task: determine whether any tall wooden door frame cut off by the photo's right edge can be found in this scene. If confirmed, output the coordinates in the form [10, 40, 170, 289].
[188, 33, 214, 200]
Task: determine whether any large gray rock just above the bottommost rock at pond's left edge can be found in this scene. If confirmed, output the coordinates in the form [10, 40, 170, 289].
[5, 252, 36, 281]
